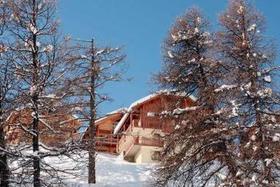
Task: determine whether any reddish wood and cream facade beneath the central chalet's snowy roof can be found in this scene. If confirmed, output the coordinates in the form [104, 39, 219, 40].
[117, 94, 194, 161]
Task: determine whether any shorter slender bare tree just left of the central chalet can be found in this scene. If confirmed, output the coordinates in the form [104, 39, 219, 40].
[68, 40, 125, 183]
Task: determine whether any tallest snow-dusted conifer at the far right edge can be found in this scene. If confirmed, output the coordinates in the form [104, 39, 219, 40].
[217, 0, 280, 186]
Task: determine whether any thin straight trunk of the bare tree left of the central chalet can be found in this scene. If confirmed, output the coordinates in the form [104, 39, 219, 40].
[88, 40, 96, 184]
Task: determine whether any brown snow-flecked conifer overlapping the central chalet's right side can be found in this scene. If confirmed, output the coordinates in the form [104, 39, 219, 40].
[156, 9, 235, 186]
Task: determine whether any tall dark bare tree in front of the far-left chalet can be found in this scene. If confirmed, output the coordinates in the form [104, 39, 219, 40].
[1, 0, 83, 187]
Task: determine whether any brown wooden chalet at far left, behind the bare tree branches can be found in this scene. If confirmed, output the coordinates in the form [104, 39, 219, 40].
[4, 109, 81, 147]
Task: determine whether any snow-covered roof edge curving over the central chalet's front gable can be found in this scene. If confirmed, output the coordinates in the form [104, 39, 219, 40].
[114, 90, 197, 134]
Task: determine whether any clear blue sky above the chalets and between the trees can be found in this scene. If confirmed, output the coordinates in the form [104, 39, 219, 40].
[58, 0, 280, 115]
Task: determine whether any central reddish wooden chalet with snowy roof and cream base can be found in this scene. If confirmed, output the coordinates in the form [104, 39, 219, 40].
[84, 92, 195, 163]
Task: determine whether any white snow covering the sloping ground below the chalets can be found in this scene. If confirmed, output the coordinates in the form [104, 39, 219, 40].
[10, 150, 153, 187]
